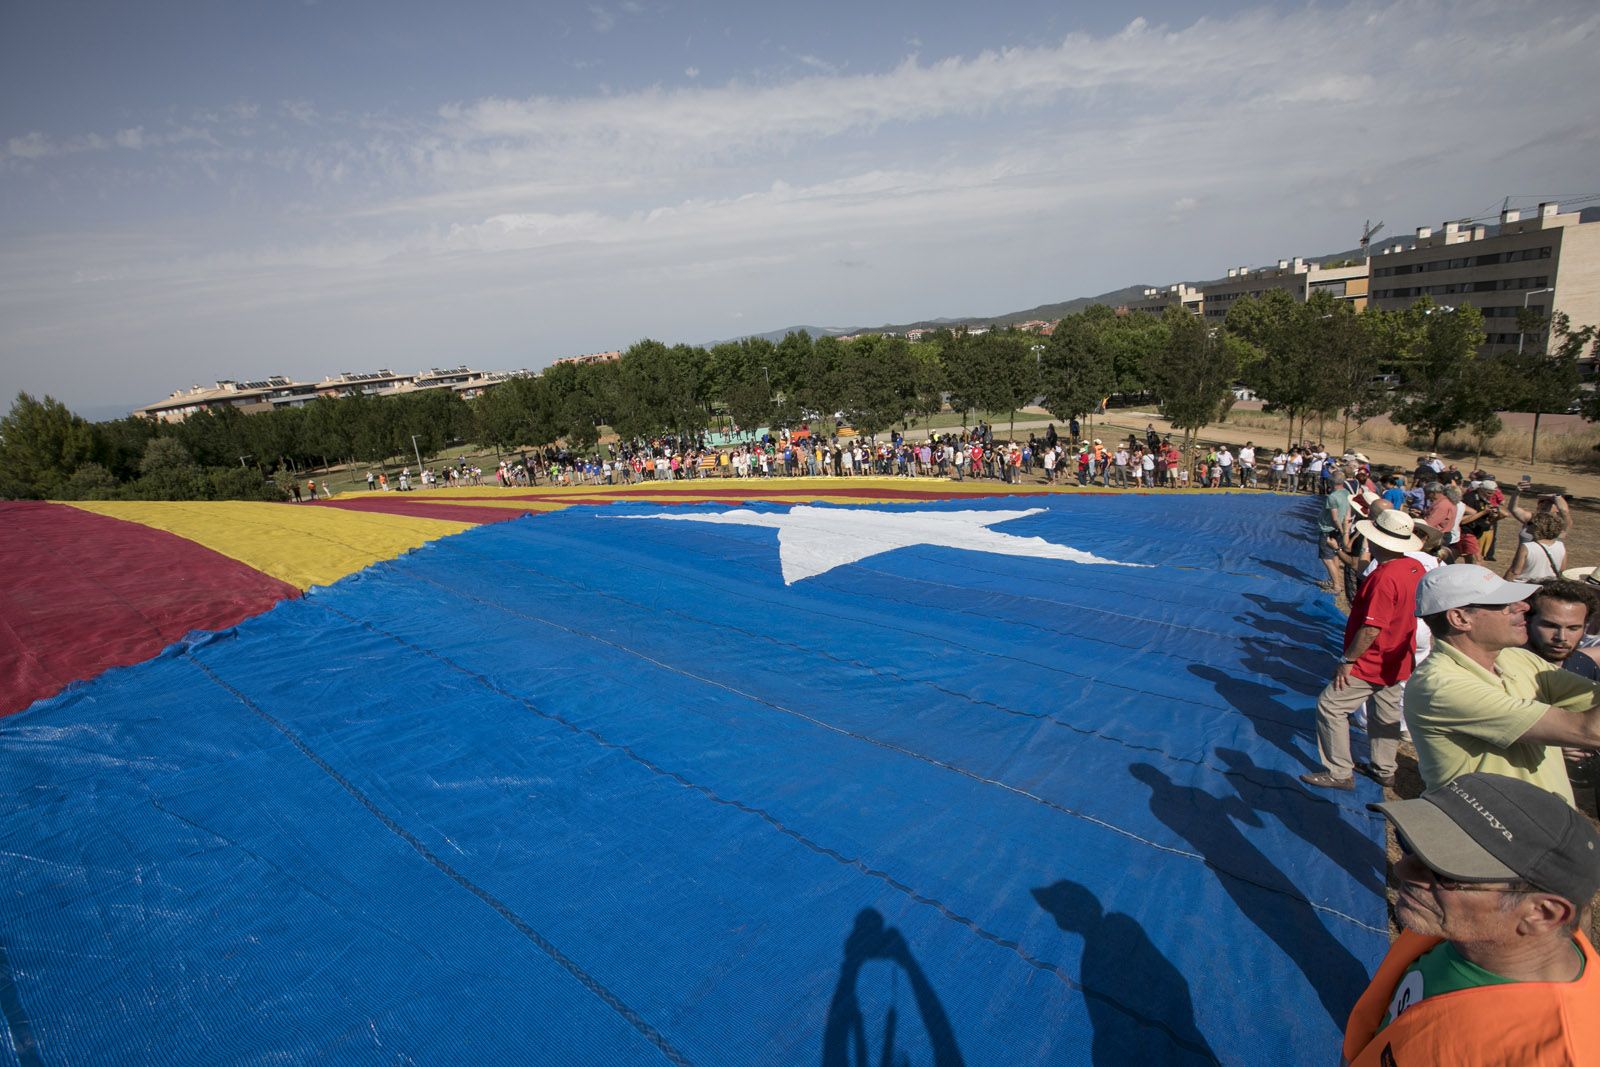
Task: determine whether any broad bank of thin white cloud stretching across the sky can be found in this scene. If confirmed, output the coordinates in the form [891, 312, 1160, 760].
[0, 0, 1600, 412]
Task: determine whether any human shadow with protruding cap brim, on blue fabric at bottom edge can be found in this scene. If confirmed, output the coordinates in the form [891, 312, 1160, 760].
[1032, 880, 1219, 1067]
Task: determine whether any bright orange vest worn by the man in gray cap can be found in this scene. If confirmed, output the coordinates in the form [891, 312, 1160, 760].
[1344, 929, 1600, 1067]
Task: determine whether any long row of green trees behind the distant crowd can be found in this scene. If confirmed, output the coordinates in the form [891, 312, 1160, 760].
[0, 293, 1600, 499]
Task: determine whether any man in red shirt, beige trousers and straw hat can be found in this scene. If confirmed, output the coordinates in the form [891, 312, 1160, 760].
[1301, 509, 1424, 789]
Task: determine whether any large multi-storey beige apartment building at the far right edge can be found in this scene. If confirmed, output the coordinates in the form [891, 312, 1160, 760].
[1371, 203, 1600, 352]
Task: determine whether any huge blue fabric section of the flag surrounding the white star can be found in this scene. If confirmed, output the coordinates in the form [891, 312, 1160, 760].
[0, 494, 1387, 1064]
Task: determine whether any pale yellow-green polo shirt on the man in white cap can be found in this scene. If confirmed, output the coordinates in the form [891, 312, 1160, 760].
[1405, 641, 1597, 803]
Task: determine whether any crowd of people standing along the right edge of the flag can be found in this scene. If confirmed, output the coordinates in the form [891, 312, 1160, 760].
[1301, 456, 1600, 1067]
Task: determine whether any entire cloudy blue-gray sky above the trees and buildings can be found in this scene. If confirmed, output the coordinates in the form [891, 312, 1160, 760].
[0, 0, 1600, 418]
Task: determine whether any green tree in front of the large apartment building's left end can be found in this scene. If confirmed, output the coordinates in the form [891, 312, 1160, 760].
[1394, 298, 1504, 451]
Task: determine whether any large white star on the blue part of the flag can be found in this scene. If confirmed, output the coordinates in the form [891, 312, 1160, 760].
[616, 504, 1150, 585]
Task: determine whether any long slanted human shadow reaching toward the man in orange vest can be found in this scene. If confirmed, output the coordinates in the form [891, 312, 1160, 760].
[1128, 763, 1366, 1027]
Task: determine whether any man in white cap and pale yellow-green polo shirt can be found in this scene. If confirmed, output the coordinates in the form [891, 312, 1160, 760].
[1405, 563, 1600, 803]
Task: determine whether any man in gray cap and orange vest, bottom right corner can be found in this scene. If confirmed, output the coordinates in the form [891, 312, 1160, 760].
[1342, 774, 1600, 1067]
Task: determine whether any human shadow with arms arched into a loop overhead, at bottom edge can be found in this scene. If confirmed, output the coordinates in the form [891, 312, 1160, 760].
[822, 907, 963, 1067]
